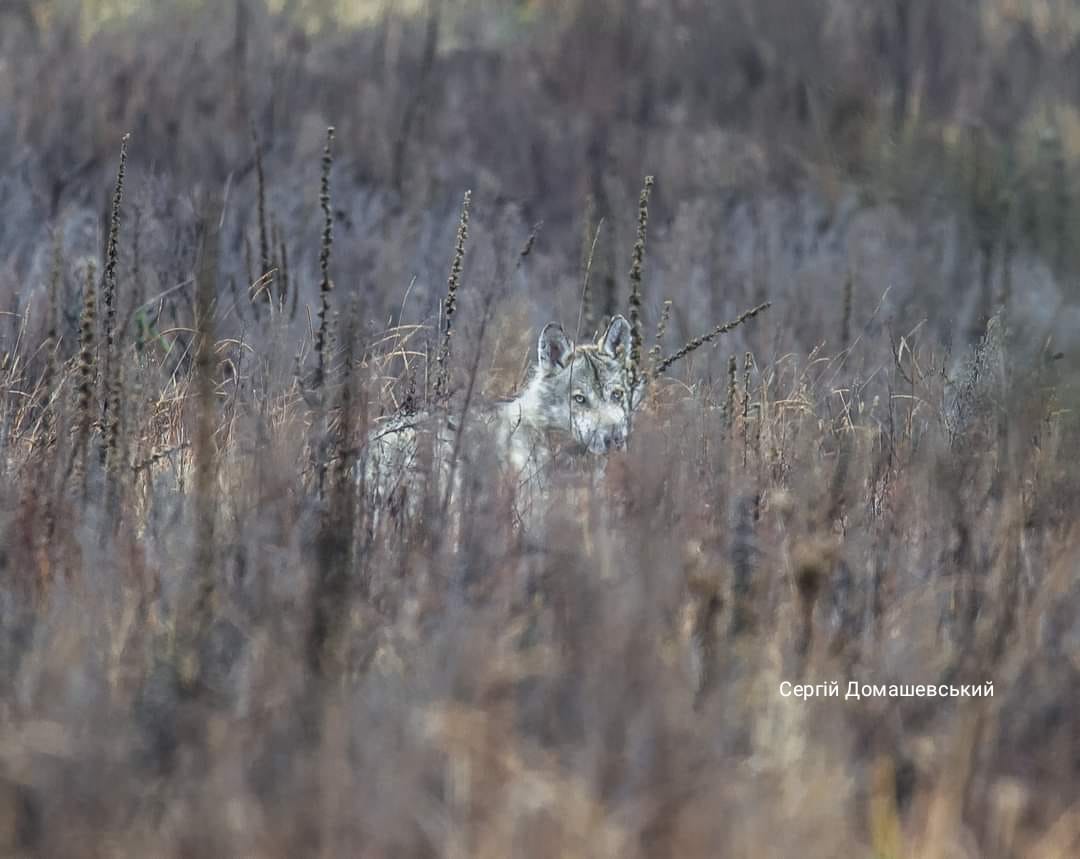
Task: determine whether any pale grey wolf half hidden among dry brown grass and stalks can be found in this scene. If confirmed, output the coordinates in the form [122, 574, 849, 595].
[357, 316, 647, 531]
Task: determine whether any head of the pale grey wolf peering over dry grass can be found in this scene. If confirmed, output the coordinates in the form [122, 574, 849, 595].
[528, 316, 645, 454]
